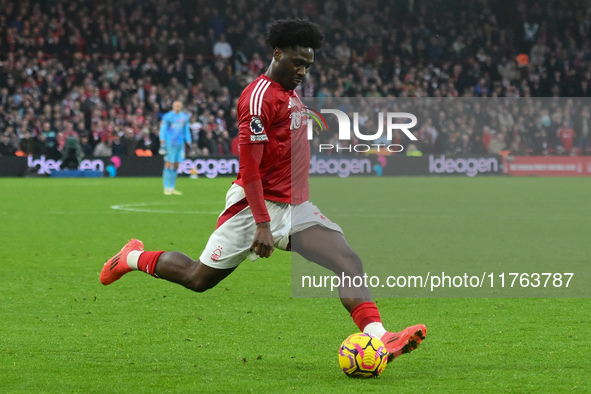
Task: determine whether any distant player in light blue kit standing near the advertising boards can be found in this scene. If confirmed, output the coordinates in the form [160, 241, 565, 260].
[159, 100, 191, 196]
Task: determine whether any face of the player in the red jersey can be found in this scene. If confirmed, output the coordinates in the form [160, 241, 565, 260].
[275, 47, 314, 90]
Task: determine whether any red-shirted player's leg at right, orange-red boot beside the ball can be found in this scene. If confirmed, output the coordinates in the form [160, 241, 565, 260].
[291, 224, 427, 360]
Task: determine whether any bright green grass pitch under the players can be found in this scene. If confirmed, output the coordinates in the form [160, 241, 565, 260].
[0, 178, 591, 393]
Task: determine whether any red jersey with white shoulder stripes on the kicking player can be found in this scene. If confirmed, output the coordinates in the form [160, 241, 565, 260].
[235, 75, 310, 204]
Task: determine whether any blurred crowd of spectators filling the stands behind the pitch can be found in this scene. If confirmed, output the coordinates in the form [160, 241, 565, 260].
[0, 0, 591, 158]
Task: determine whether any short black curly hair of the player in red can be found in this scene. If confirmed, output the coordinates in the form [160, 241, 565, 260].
[266, 18, 324, 49]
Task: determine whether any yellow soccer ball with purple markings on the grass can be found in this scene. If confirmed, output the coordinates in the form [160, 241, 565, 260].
[339, 332, 388, 378]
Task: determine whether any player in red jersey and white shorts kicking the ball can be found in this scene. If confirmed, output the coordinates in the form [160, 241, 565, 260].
[101, 19, 427, 359]
